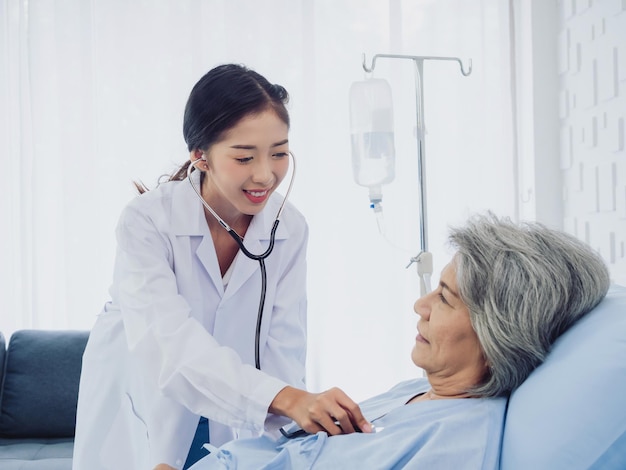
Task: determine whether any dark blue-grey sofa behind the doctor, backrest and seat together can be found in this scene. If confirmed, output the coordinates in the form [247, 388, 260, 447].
[0, 330, 89, 470]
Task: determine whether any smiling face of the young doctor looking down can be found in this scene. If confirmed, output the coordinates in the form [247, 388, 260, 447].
[191, 110, 289, 220]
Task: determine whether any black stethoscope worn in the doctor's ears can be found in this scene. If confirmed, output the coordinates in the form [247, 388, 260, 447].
[187, 151, 296, 370]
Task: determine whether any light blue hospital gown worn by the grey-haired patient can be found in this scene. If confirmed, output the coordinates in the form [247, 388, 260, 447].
[191, 379, 506, 470]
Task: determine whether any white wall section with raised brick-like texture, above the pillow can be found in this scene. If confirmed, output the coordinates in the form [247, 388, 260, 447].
[558, 0, 626, 285]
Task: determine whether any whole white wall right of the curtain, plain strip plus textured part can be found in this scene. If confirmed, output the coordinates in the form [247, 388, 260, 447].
[512, 0, 626, 284]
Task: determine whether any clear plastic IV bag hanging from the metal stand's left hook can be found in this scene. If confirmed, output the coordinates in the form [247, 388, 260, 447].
[350, 78, 395, 188]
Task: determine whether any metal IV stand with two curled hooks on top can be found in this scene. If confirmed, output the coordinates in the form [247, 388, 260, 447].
[363, 54, 472, 296]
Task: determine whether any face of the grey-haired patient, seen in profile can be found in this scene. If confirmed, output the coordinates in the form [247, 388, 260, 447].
[411, 260, 487, 387]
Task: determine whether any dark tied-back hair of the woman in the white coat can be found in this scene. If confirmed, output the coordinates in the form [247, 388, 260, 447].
[135, 64, 290, 193]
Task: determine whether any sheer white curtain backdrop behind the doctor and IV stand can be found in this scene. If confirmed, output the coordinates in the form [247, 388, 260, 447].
[0, 0, 516, 399]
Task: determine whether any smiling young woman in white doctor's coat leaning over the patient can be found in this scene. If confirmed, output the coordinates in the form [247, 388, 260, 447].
[73, 64, 370, 470]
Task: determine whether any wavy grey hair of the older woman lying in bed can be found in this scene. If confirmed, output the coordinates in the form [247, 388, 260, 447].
[449, 213, 610, 397]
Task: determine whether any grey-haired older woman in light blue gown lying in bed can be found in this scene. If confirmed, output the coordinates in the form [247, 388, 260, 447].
[173, 214, 609, 470]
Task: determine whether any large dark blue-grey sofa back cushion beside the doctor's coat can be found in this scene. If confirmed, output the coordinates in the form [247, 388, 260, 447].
[0, 330, 89, 438]
